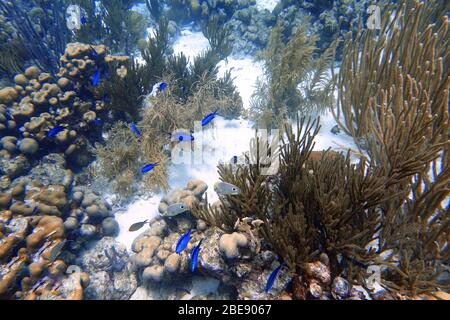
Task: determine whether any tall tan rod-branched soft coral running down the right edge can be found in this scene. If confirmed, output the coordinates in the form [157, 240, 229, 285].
[335, 1, 450, 294]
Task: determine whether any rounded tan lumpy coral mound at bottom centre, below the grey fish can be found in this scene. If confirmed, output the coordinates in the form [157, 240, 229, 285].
[131, 180, 289, 299]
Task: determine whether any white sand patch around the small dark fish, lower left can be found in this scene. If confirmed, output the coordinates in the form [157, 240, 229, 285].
[115, 195, 161, 252]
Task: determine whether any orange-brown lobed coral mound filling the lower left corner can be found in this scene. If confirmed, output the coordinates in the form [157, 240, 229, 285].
[0, 154, 117, 299]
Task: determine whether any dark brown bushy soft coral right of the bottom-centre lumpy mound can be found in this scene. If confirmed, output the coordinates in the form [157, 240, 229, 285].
[193, 107, 446, 298]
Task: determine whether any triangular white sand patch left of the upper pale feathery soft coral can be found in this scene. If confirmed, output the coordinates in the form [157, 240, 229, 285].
[219, 57, 263, 109]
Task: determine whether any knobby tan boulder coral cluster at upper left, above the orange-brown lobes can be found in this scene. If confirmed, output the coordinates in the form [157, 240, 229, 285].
[0, 43, 128, 165]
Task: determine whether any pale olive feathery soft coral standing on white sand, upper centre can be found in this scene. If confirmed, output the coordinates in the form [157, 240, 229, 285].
[251, 23, 337, 128]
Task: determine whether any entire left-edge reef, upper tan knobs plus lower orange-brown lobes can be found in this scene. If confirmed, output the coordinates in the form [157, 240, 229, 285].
[0, 43, 127, 299]
